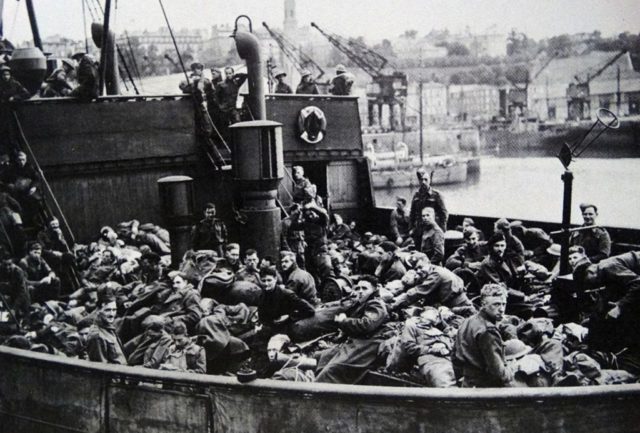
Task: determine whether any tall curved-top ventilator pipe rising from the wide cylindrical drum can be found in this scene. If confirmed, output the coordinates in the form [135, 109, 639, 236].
[233, 31, 267, 120]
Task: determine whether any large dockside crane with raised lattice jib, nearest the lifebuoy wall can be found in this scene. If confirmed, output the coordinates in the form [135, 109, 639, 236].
[311, 23, 408, 130]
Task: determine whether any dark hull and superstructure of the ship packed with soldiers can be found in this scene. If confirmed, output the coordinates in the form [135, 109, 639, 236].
[0, 4, 640, 433]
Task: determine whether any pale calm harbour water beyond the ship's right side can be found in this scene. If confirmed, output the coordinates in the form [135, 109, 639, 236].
[375, 157, 640, 228]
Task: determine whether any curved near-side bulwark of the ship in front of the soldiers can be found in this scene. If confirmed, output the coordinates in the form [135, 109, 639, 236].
[0, 347, 640, 433]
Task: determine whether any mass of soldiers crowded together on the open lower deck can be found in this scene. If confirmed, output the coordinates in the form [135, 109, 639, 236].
[0, 159, 640, 387]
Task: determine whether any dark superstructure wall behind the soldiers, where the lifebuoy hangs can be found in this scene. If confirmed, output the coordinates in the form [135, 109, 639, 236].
[5, 95, 373, 241]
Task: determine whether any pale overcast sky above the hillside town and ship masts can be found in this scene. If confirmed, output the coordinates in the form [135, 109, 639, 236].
[0, 0, 640, 42]
